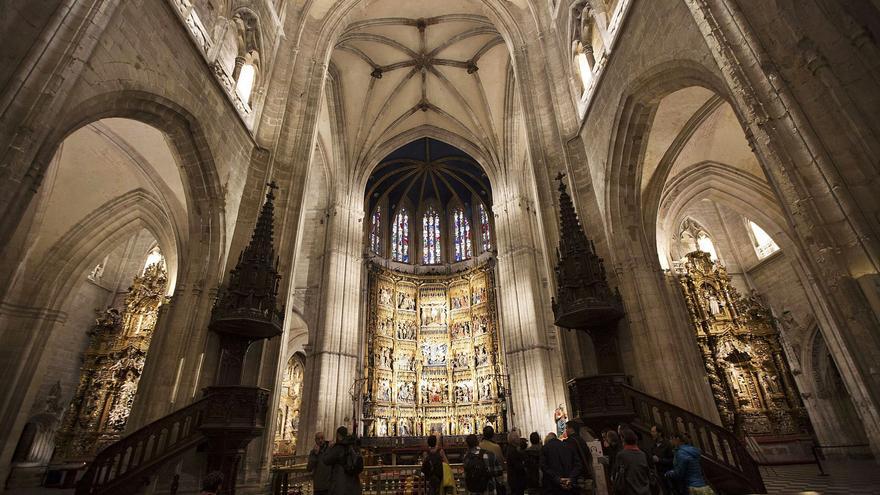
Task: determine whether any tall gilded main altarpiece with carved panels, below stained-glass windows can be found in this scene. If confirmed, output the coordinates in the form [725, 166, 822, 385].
[364, 264, 506, 437]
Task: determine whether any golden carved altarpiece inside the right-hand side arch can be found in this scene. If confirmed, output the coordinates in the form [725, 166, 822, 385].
[676, 251, 809, 437]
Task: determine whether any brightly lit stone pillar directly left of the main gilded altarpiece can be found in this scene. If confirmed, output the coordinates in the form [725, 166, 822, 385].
[297, 200, 364, 446]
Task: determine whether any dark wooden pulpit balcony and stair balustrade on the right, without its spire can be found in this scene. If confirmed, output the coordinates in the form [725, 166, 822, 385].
[569, 375, 767, 493]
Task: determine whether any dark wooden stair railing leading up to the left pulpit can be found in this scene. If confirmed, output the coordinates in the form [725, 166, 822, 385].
[76, 397, 210, 495]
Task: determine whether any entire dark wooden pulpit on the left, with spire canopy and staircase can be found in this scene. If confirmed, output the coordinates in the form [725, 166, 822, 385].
[76, 183, 283, 495]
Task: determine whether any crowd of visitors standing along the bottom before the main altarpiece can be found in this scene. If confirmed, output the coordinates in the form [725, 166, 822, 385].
[308, 420, 714, 495]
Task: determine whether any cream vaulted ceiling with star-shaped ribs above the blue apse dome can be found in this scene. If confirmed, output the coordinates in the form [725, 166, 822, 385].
[331, 1, 512, 170]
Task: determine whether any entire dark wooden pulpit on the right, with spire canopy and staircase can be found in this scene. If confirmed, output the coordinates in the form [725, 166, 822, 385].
[553, 174, 766, 493]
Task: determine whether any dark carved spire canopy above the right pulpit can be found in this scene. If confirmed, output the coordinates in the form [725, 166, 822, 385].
[553, 173, 623, 330]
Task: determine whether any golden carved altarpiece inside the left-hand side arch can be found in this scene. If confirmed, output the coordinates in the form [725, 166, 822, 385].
[55, 260, 168, 460]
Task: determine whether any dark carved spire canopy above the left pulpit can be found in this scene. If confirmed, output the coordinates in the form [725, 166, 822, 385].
[211, 182, 283, 339]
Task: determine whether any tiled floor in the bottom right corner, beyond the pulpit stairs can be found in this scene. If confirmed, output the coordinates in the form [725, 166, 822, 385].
[761, 461, 880, 495]
